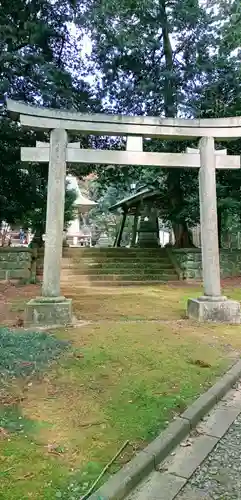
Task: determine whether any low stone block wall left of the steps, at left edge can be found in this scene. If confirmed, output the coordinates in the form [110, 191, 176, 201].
[0, 247, 32, 280]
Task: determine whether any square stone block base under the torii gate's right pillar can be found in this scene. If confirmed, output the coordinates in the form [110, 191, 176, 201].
[187, 296, 241, 325]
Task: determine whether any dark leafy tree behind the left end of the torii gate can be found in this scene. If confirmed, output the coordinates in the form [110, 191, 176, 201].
[0, 0, 98, 229]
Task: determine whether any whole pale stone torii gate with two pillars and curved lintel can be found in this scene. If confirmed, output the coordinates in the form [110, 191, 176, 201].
[7, 100, 241, 326]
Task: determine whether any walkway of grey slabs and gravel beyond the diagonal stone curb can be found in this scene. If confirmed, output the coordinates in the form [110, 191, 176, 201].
[128, 384, 241, 500]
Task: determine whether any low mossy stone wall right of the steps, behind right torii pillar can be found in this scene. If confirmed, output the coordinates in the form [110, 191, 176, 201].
[171, 248, 241, 280]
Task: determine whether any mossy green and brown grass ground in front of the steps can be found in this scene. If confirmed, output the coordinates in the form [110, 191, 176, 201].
[0, 286, 241, 500]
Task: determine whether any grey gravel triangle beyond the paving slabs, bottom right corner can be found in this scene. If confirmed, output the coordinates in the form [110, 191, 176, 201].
[177, 414, 241, 500]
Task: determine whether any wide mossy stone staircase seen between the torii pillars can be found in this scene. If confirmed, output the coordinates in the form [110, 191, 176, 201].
[61, 248, 178, 287]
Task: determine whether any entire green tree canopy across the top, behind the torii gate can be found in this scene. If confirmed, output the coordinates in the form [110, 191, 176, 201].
[0, 0, 241, 246]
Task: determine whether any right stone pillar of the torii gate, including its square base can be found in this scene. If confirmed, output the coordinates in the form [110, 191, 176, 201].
[187, 137, 240, 323]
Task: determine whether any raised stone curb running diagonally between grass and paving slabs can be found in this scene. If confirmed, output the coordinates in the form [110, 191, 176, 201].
[89, 360, 241, 500]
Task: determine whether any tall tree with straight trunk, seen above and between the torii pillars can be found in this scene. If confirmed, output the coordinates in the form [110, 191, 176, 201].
[76, 0, 215, 246]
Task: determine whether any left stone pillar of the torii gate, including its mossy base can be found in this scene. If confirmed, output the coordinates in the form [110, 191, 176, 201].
[26, 129, 72, 326]
